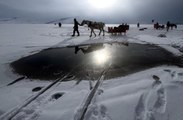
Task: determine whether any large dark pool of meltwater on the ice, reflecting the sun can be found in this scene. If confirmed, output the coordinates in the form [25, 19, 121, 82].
[11, 43, 179, 80]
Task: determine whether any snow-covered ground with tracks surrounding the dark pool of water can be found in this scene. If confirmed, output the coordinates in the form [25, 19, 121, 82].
[0, 24, 183, 120]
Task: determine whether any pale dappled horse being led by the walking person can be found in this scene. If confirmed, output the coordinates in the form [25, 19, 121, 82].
[81, 20, 105, 37]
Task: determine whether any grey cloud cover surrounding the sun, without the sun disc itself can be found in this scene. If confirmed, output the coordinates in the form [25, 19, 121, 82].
[0, 0, 183, 23]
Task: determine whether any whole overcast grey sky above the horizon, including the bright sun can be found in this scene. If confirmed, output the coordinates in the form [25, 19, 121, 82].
[0, 0, 183, 23]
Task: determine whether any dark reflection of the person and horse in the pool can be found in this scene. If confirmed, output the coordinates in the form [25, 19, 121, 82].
[75, 44, 104, 54]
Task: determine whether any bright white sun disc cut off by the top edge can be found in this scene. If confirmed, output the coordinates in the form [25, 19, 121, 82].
[88, 0, 116, 9]
